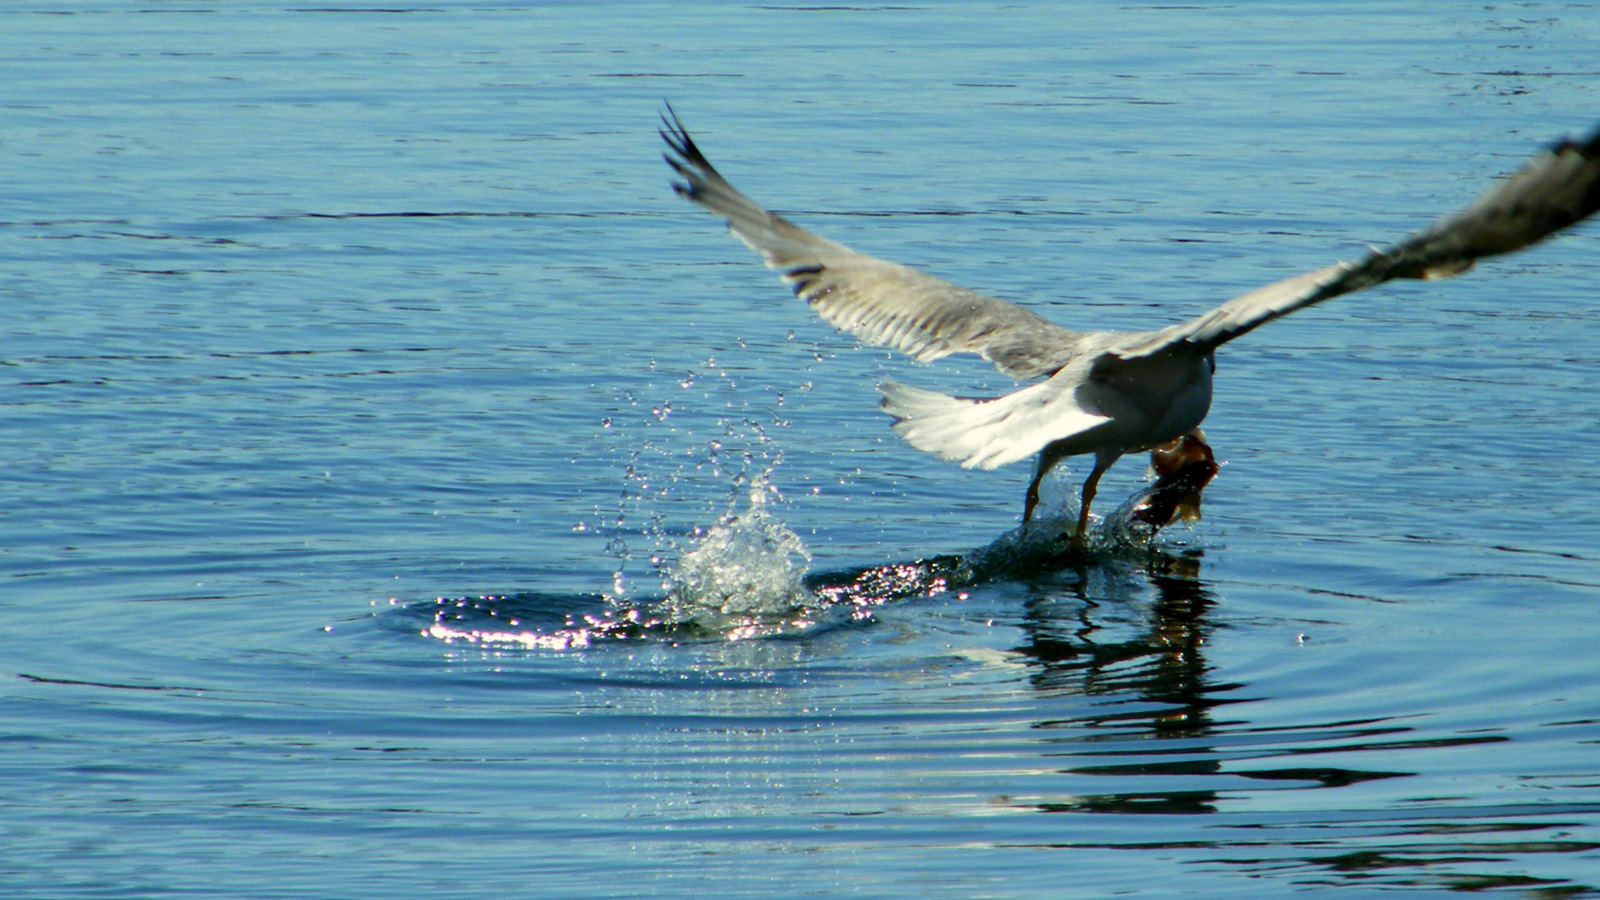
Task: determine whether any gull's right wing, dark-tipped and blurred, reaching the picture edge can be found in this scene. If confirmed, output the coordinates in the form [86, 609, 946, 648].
[1117, 128, 1600, 359]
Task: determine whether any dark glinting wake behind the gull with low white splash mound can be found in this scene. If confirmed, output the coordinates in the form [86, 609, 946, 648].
[410, 469, 1203, 650]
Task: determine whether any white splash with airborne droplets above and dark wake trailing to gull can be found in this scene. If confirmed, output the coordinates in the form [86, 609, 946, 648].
[410, 344, 1209, 650]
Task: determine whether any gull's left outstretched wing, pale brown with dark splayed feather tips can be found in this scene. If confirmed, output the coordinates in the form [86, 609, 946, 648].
[661, 106, 1078, 380]
